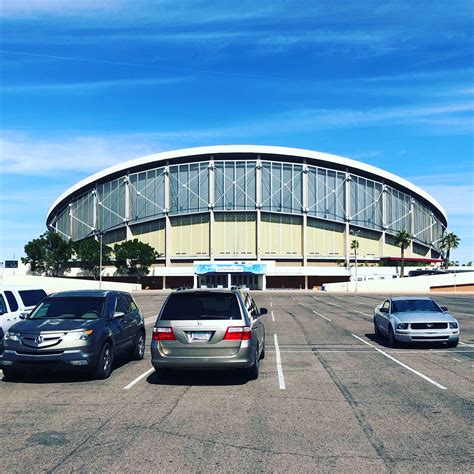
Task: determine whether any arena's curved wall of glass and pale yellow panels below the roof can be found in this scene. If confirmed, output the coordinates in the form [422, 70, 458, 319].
[49, 156, 443, 257]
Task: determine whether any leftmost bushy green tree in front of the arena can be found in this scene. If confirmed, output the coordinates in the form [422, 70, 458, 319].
[21, 230, 72, 277]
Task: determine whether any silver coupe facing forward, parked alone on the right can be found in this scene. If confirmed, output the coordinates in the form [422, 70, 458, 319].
[374, 297, 460, 347]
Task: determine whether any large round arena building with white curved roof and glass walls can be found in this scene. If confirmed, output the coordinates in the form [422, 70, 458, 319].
[47, 145, 447, 289]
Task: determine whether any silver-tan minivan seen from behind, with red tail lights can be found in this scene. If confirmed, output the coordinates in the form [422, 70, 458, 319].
[151, 289, 267, 379]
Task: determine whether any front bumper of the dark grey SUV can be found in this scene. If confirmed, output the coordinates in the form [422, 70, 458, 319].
[0, 349, 99, 370]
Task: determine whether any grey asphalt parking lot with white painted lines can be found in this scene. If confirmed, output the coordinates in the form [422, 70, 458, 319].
[0, 291, 474, 472]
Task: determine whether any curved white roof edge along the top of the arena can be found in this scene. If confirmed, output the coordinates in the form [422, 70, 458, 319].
[46, 145, 448, 224]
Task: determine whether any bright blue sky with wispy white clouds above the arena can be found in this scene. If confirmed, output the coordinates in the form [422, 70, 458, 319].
[0, 0, 474, 263]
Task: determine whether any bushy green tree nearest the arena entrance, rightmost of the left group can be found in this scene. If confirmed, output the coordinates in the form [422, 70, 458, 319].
[114, 239, 158, 281]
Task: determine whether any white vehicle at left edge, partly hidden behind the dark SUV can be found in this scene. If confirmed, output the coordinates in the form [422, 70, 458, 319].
[0, 286, 47, 339]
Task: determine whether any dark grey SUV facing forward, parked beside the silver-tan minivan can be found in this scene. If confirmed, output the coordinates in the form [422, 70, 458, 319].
[0, 290, 145, 379]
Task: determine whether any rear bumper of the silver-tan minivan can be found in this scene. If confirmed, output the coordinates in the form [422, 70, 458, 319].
[151, 341, 256, 369]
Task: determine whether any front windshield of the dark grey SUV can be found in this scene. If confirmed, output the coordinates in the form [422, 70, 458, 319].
[29, 296, 105, 319]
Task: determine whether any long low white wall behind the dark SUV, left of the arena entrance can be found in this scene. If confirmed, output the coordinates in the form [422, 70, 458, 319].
[0, 275, 141, 293]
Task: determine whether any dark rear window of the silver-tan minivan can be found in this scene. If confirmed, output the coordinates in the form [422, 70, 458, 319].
[160, 292, 241, 321]
